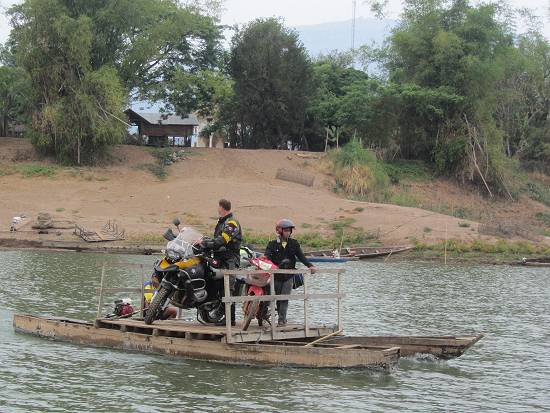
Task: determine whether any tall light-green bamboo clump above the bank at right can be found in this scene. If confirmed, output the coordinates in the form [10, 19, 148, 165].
[387, 0, 514, 194]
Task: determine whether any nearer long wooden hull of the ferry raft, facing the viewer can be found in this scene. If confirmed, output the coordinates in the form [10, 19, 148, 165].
[13, 315, 400, 371]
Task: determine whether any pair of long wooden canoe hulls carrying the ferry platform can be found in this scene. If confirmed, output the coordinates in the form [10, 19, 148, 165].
[13, 314, 482, 371]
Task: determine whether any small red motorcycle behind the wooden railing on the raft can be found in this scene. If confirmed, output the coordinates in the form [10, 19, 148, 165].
[239, 256, 279, 330]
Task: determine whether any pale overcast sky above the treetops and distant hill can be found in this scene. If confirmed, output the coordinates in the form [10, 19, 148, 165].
[0, 0, 550, 43]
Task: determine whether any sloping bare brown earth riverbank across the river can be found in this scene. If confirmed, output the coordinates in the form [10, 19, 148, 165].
[0, 138, 550, 250]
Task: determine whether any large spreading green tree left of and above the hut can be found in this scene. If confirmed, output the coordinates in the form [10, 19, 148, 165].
[5, 0, 219, 164]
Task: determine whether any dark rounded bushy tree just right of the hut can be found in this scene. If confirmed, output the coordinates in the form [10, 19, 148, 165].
[230, 18, 311, 148]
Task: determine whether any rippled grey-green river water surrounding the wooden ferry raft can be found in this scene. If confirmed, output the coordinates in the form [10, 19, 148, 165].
[0, 251, 550, 413]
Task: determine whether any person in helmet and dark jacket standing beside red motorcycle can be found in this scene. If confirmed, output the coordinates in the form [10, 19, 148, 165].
[265, 219, 315, 326]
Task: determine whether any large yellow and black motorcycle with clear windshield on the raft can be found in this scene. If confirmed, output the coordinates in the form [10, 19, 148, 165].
[144, 218, 225, 324]
